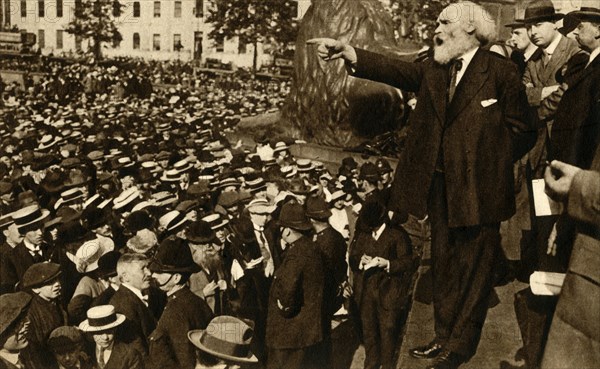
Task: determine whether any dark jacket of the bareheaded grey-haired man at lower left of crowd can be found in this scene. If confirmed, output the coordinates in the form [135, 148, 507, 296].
[110, 285, 156, 355]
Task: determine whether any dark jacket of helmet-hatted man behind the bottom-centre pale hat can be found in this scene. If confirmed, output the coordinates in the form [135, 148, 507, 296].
[146, 287, 213, 369]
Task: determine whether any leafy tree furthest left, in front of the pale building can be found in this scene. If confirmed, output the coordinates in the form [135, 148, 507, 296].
[66, 0, 123, 59]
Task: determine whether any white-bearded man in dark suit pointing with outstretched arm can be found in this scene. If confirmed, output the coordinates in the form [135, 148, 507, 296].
[307, 1, 535, 369]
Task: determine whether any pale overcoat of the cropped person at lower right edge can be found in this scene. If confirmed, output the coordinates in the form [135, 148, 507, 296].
[541, 139, 600, 369]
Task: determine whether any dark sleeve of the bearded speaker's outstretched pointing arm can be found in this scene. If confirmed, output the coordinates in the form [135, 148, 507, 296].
[352, 48, 424, 92]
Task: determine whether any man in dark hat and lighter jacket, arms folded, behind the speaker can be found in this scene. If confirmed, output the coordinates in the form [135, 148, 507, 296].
[523, 0, 581, 177]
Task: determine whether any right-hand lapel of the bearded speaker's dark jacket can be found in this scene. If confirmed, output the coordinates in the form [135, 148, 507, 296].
[446, 49, 489, 124]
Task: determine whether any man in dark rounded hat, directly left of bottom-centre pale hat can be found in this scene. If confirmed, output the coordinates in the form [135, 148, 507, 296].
[147, 238, 213, 369]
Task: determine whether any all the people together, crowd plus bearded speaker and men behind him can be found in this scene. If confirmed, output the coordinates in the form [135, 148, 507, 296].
[0, 0, 600, 369]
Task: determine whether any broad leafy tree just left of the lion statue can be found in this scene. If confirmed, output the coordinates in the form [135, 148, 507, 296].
[206, 0, 297, 70]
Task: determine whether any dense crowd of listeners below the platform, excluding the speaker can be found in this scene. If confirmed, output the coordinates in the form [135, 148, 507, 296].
[0, 29, 418, 368]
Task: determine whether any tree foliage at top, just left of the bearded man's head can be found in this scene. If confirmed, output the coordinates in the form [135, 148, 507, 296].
[389, 0, 456, 44]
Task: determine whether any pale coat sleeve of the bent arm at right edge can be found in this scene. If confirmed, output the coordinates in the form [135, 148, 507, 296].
[567, 170, 600, 227]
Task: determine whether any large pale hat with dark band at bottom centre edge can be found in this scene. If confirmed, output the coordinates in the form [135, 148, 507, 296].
[188, 315, 258, 364]
